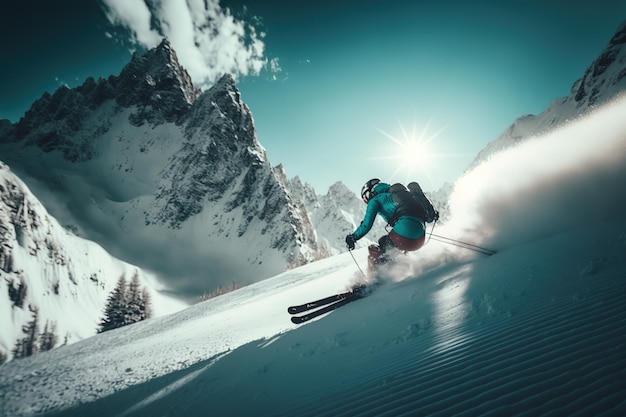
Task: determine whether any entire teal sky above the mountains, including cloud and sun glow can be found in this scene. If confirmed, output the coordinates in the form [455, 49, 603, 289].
[0, 0, 626, 194]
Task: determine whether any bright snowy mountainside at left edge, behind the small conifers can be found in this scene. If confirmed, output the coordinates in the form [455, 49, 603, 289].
[0, 163, 186, 358]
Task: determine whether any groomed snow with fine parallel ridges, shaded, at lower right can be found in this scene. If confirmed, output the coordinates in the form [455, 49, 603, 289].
[277, 272, 626, 417]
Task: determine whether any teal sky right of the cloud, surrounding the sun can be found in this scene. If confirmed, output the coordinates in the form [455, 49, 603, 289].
[232, 0, 626, 193]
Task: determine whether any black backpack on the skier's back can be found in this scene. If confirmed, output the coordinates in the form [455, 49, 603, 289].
[389, 182, 439, 227]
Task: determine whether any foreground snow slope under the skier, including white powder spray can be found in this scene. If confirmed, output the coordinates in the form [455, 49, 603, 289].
[0, 96, 626, 416]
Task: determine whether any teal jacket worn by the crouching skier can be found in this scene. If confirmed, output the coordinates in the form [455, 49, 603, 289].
[353, 182, 426, 240]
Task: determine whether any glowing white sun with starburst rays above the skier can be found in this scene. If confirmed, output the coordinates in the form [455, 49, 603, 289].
[376, 118, 445, 182]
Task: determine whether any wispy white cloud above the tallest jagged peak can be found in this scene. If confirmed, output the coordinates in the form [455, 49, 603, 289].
[102, 0, 271, 88]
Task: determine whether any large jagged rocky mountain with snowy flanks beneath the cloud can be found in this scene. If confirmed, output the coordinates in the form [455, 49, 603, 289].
[0, 40, 320, 295]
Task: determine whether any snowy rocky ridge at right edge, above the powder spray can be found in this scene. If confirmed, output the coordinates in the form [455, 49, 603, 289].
[468, 21, 626, 170]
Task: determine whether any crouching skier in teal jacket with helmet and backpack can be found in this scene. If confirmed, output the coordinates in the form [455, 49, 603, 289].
[346, 178, 439, 271]
